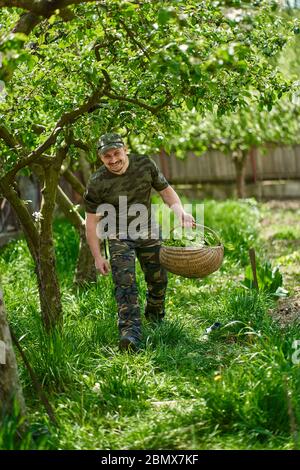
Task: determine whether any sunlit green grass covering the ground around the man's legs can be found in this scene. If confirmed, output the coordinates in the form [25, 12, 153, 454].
[0, 201, 300, 449]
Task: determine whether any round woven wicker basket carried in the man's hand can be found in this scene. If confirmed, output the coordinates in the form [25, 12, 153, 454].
[159, 224, 224, 278]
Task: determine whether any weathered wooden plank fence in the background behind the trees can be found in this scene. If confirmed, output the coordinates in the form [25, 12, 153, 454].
[0, 145, 300, 239]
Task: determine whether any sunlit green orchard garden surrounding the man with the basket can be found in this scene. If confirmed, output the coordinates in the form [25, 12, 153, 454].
[0, 0, 300, 451]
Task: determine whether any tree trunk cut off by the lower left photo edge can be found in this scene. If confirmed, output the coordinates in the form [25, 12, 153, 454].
[0, 288, 25, 423]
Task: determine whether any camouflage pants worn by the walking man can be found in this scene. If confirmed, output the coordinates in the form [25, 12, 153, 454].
[109, 239, 168, 339]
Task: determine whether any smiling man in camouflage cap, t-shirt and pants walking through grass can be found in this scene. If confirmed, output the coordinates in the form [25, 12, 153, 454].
[84, 133, 195, 350]
